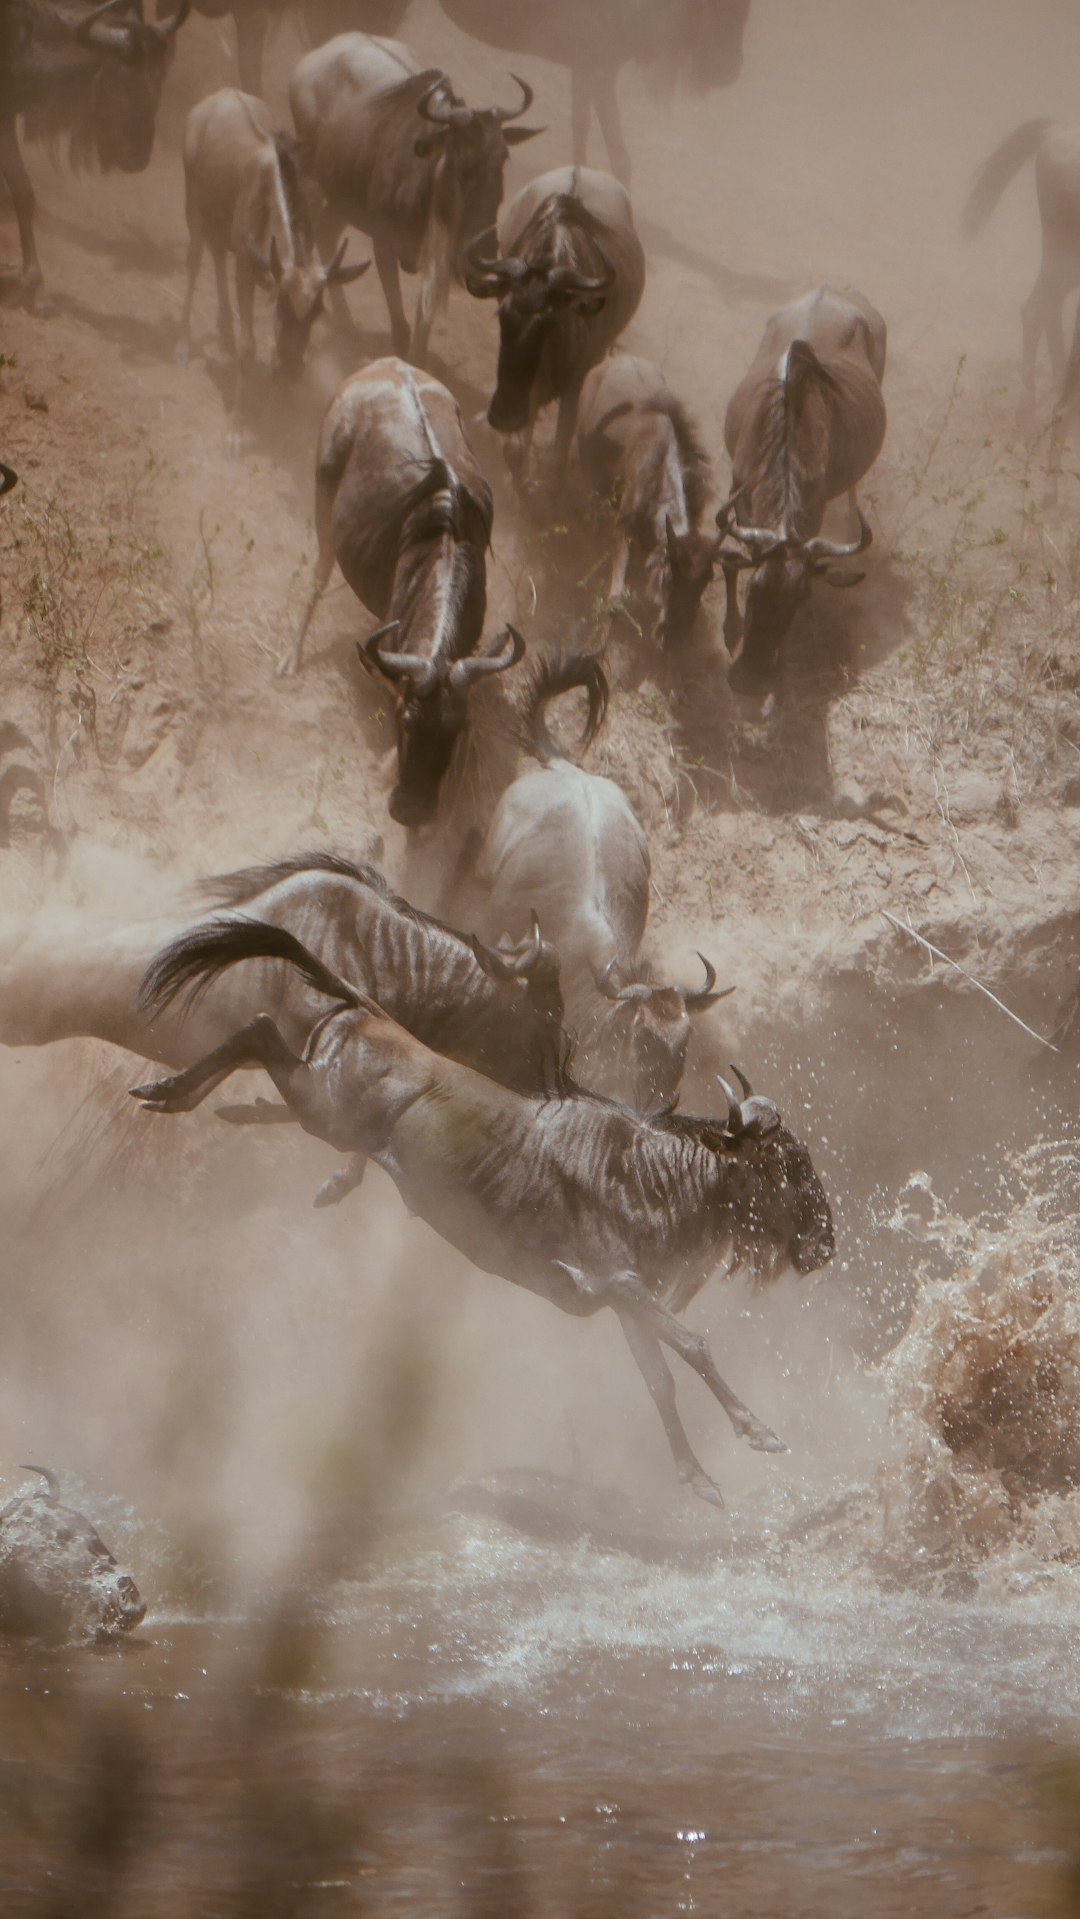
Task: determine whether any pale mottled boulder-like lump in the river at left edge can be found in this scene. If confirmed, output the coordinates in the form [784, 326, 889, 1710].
[0, 1466, 146, 1641]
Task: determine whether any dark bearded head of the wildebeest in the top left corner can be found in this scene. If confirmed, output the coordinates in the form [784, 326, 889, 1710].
[71, 0, 192, 173]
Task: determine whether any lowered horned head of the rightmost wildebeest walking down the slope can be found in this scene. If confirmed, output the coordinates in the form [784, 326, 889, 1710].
[716, 495, 873, 693]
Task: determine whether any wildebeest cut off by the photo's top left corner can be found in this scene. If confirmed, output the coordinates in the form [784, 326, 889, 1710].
[0, 0, 190, 299]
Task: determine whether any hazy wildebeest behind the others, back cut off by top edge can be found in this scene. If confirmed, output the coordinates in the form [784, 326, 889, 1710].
[439, 0, 750, 182]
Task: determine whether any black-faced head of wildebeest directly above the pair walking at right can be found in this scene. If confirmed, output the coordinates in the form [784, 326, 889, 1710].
[464, 224, 616, 434]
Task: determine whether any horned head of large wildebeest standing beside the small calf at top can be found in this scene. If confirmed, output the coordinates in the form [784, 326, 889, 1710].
[414, 73, 543, 276]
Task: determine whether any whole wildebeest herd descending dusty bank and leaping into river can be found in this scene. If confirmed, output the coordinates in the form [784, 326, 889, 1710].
[0, 0, 1080, 1623]
